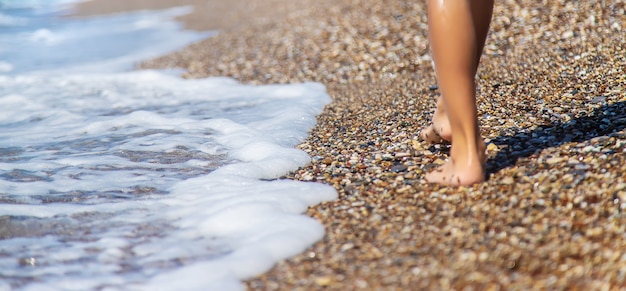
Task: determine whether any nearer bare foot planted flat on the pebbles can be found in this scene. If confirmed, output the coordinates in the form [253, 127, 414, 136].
[424, 141, 486, 186]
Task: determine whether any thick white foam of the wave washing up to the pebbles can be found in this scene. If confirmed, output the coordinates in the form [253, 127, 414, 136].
[0, 71, 336, 289]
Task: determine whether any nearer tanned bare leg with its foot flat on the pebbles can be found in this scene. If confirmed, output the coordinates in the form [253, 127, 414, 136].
[426, 0, 493, 185]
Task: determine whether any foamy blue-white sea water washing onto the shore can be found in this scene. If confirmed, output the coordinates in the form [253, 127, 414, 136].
[0, 0, 336, 290]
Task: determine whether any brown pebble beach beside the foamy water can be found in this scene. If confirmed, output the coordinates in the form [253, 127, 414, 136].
[79, 0, 626, 290]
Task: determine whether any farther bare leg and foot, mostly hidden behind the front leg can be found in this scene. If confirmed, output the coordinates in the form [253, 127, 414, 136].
[420, 0, 493, 143]
